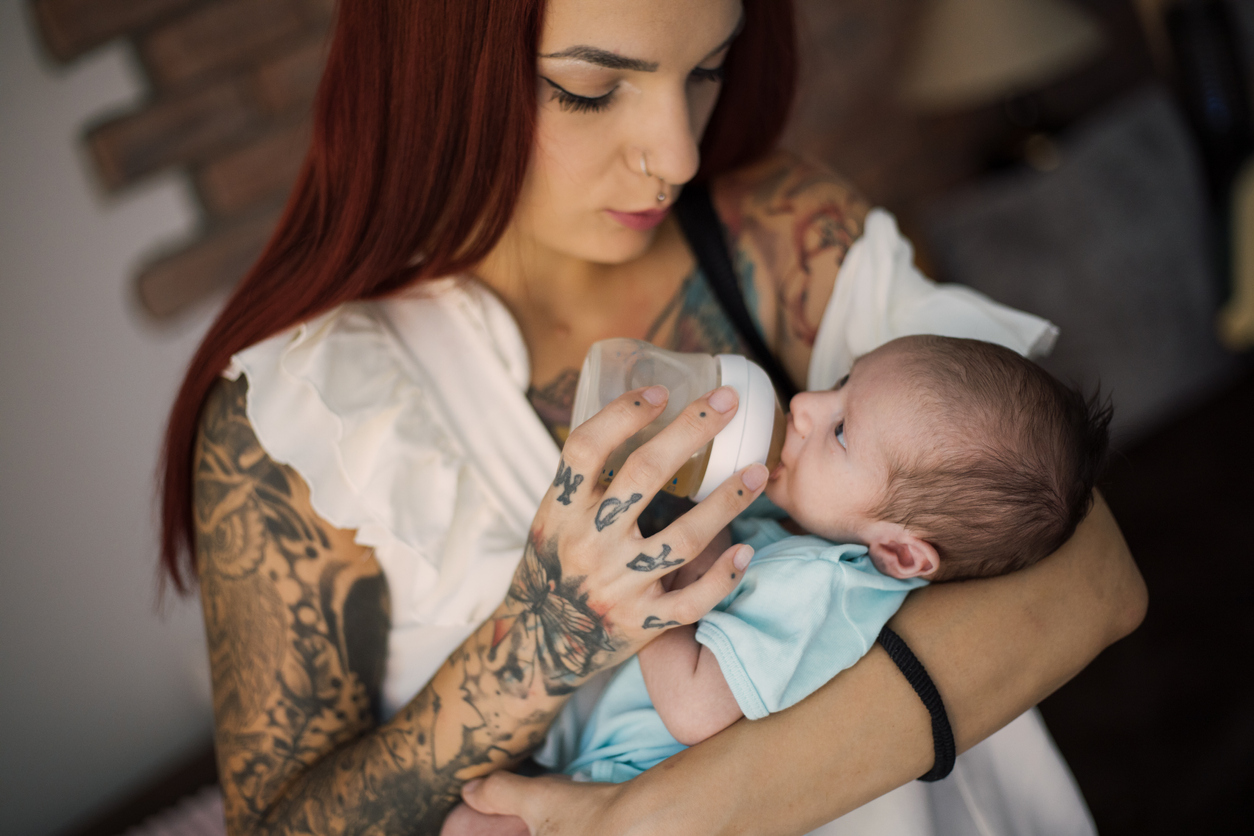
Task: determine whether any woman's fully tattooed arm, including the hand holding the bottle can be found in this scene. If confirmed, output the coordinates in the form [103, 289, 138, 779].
[194, 379, 765, 835]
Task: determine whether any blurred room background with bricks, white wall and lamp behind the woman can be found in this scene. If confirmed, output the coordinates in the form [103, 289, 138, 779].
[0, 0, 1254, 836]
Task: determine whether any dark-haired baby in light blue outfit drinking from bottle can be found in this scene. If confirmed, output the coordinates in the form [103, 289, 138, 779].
[561, 336, 1111, 781]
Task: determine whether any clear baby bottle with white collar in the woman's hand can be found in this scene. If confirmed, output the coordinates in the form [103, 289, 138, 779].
[571, 338, 786, 501]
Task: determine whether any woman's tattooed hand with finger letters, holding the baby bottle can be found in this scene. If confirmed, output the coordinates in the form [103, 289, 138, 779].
[493, 386, 767, 696]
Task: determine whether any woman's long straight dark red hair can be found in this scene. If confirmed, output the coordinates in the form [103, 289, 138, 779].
[159, 0, 796, 592]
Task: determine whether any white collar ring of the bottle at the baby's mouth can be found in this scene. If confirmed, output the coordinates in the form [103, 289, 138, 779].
[693, 355, 775, 503]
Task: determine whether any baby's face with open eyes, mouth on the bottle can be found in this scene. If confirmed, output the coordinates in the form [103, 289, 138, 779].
[766, 345, 925, 543]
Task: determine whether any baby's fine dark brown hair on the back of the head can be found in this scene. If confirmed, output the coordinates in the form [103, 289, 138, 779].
[873, 336, 1112, 580]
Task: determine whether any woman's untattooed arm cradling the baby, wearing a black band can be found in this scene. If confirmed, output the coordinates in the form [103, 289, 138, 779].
[465, 498, 1146, 836]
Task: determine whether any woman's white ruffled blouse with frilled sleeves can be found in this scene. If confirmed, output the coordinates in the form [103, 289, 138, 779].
[227, 209, 1057, 716]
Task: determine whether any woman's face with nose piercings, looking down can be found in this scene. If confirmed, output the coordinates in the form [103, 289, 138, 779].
[514, 0, 741, 264]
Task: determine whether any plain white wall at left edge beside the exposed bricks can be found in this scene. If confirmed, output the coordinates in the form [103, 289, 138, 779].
[0, 0, 225, 836]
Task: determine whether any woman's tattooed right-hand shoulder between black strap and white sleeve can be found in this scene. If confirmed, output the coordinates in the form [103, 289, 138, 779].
[711, 152, 870, 381]
